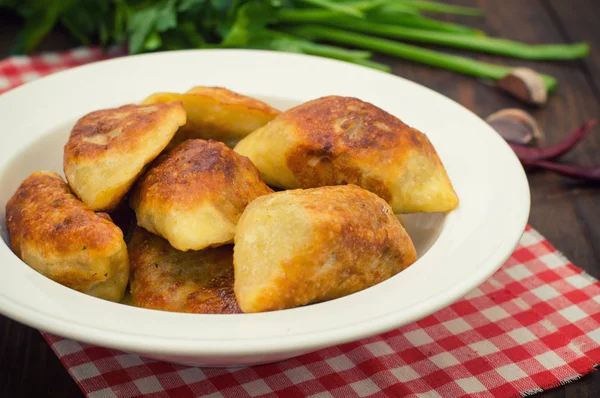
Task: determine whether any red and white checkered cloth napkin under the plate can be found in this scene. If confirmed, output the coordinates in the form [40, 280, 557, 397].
[0, 49, 600, 398]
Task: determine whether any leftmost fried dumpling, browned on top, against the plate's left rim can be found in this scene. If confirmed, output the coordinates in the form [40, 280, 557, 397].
[6, 171, 129, 301]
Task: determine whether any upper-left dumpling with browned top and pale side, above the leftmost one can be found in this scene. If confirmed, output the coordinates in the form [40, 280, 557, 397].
[64, 102, 185, 210]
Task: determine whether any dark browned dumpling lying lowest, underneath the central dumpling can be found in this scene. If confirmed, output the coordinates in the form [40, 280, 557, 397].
[129, 227, 240, 314]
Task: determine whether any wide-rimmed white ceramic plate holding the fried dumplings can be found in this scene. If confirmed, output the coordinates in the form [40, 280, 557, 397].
[0, 50, 529, 366]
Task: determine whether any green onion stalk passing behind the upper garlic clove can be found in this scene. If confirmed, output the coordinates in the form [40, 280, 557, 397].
[286, 25, 557, 91]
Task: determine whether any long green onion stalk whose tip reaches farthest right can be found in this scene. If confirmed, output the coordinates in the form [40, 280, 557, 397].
[308, 16, 589, 60]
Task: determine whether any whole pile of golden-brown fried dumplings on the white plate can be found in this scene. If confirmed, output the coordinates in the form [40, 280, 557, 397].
[7, 87, 458, 314]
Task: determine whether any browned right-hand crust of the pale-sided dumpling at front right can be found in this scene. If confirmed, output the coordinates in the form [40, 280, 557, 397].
[280, 185, 417, 301]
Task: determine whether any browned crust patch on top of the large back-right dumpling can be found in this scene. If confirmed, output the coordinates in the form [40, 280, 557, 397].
[284, 96, 443, 201]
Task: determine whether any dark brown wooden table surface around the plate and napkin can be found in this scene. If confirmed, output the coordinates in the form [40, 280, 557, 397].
[0, 0, 600, 398]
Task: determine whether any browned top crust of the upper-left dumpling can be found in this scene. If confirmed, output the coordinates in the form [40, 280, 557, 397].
[64, 101, 185, 162]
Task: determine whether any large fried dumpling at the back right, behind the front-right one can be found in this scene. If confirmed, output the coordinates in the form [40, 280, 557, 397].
[235, 96, 458, 213]
